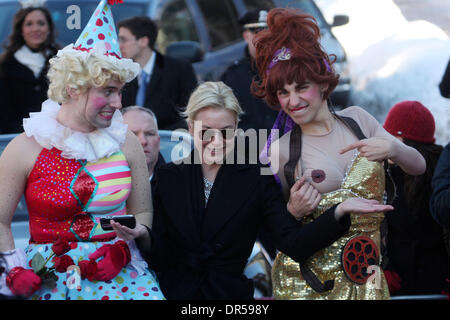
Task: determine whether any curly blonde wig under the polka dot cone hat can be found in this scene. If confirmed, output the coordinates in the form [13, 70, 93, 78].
[47, 55, 132, 103]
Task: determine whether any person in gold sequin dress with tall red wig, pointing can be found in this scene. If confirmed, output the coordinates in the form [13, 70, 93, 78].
[253, 9, 425, 299]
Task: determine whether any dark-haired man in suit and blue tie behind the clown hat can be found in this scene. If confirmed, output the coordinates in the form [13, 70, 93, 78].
[118, 16, 197, 130]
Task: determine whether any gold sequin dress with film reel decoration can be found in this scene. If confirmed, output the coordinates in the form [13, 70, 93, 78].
[272, 155, 389, 300]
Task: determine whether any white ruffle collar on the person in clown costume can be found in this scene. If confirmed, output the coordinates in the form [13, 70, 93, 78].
[23, 99, 128, 162]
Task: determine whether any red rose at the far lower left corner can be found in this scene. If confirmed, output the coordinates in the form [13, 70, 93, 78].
[6, 267, 42, 297]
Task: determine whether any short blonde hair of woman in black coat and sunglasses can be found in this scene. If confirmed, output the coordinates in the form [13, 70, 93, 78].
[182, 81, 244, 124]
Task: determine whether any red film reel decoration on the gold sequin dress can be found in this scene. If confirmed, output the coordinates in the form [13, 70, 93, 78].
[341, 236, 380, 284]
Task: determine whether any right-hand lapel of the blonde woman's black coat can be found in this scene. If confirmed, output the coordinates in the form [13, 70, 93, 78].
[201, 164, 257, 241]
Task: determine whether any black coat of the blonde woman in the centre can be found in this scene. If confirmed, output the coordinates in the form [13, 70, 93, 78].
[145, 154, 350, 300]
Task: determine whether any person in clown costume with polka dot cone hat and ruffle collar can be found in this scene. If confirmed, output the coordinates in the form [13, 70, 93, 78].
[0, 0, 164, 300]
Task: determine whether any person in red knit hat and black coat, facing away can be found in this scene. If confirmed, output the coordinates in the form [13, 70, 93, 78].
[383, 101, 449, 295]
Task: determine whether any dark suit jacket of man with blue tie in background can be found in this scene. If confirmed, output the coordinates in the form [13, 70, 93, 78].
[122, 51, 197, 130]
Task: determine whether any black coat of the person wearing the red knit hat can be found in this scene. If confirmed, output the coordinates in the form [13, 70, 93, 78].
[384, 165, 450, 295]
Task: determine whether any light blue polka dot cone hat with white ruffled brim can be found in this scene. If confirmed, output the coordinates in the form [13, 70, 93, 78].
[57, 0, 140, 82]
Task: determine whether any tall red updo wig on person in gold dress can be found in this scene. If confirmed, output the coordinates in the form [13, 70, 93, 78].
[252, 8, 339, 108]
